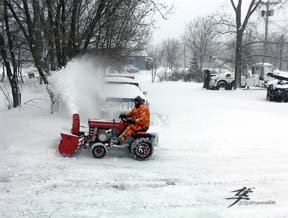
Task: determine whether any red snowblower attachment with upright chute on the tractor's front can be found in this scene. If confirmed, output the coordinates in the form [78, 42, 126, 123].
[59, 114, 80, 157]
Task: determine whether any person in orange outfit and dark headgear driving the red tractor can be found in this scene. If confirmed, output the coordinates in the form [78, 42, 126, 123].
[111, 96, 150, 144]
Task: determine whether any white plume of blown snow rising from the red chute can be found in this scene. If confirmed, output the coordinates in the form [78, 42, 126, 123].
[52, 56, 106, 118]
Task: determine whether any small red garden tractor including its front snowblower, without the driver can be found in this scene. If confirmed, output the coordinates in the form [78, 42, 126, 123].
[59, 114, 158, 160]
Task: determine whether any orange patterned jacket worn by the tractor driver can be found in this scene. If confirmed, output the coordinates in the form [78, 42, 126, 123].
[126, 103, 150, 128]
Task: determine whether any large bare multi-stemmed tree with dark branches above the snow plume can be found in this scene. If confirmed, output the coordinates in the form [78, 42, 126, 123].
[2, 0, 170, 111]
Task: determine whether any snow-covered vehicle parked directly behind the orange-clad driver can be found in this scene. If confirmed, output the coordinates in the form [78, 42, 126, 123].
[101, 74, 148, 119]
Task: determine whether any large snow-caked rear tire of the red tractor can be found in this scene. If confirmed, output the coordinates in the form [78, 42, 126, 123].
[131, 138, 154, 161]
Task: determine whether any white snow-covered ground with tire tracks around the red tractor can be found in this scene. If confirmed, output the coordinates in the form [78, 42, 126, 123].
[0, 67, 288, 218]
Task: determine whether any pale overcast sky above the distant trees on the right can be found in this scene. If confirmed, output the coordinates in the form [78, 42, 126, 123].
[153, 0, 288, 42]
